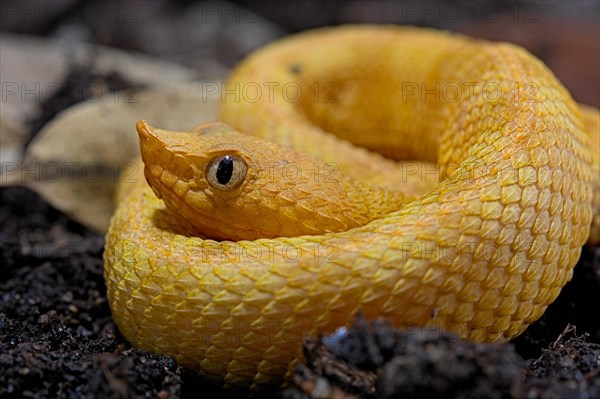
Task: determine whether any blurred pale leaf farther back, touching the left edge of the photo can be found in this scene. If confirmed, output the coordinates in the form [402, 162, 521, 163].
[0, 33, 198, 166]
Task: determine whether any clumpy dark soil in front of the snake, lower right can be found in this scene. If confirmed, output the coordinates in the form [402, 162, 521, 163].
[282, 317, 600, 399]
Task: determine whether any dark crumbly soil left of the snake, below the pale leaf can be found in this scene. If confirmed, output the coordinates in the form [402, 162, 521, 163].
[0, 188, 182, 398]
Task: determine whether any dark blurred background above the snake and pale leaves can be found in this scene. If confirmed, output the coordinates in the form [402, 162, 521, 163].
[0, 0, 600, 107]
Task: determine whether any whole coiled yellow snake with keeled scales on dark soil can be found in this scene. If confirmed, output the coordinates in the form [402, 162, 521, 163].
[105, 26, 600, 389]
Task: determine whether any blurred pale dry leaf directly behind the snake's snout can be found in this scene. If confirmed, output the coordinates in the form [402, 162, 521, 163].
[5, 82, 220, 232]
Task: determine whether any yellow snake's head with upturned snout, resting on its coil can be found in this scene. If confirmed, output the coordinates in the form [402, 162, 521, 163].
[137, 121, 403, 241]
